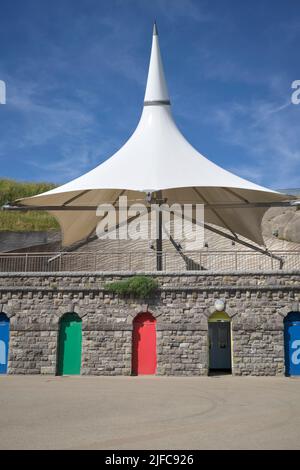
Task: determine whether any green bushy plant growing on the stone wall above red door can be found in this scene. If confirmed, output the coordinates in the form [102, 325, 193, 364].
[105, 276, 158, 298]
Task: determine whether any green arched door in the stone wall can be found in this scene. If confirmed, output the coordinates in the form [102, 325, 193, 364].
[58, 313, 82, 375]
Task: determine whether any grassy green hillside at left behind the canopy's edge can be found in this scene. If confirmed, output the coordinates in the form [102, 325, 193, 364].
[0, 179, 59, 232]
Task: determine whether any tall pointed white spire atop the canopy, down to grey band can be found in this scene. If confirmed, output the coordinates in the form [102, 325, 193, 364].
[144, 22, 171, 106]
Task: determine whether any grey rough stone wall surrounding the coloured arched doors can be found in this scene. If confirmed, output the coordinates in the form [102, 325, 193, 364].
[0, 271, 300, 376]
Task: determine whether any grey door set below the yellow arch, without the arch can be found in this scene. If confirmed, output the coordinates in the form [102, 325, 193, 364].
[208, 321, 231, 370]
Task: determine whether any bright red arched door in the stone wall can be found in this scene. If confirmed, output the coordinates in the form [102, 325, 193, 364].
[132, 312, 156, 375]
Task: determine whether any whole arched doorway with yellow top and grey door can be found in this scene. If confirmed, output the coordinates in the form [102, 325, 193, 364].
[208, 312, 231, 374]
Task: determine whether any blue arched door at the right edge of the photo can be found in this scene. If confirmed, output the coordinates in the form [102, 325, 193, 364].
[284, 312, 300, 375]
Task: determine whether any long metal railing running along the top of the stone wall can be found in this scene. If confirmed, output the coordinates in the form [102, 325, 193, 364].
[0, 250, 300, 273]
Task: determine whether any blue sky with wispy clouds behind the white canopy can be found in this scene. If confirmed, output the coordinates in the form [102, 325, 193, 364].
[0, 0, 300, 188]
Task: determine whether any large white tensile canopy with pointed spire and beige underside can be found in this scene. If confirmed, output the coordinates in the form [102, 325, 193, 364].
[16, 26, 291, 250]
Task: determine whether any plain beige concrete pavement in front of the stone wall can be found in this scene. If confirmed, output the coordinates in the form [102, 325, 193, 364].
[0, 376, 300, 449]
